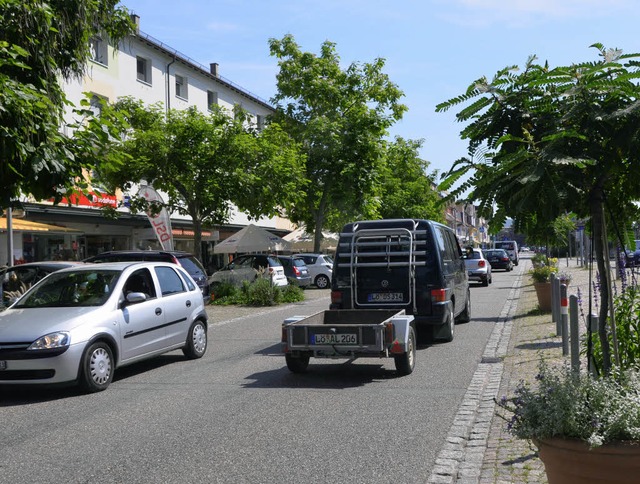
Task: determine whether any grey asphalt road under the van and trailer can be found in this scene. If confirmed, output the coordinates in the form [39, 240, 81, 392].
[0, 264, 518, 484]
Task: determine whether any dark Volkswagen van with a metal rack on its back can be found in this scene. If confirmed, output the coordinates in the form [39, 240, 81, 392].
[330, 219, 471, 341]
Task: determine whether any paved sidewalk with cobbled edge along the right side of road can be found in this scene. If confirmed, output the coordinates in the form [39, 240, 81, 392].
[428, 255, 589, 484]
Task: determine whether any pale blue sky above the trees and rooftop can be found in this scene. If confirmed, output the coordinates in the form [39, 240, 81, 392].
[117, 0, 640, 178]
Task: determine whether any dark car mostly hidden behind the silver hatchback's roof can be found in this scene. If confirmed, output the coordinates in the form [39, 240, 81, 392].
[85, 250, 211, 300]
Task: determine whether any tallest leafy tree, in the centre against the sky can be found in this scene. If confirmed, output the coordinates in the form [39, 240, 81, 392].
[269, 35, 406, 251]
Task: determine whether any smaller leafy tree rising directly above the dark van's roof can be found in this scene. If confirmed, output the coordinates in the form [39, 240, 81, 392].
[379, 137, 444, 222]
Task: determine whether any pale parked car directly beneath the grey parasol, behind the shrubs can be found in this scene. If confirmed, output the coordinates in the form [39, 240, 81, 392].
[209, 254, 288, 286]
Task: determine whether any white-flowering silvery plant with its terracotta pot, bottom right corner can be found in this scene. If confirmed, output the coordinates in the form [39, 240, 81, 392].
[497, 361, 640, 483]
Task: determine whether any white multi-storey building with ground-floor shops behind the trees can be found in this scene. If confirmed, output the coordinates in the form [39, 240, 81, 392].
[0, 16, 292, 269]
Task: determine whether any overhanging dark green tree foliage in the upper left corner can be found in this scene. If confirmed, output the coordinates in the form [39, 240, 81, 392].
[0, 0, 133, 208]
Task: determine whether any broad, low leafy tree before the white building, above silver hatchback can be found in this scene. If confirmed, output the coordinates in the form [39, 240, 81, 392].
[98, 97, 301, 259]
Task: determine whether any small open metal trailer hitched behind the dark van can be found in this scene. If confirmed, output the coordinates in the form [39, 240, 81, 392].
[282, 309, 416, 375]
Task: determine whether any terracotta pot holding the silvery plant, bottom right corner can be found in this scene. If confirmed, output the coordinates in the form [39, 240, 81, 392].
[534, 439, 640, 484]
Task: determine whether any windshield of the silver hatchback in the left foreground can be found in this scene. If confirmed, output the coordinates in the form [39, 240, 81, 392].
[14, 269, 121, 308]
